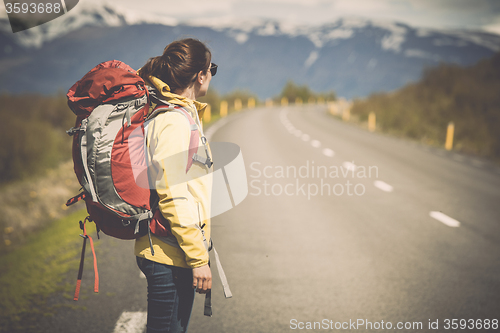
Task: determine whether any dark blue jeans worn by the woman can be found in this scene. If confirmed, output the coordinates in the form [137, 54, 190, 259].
[137, 257, 195, 333]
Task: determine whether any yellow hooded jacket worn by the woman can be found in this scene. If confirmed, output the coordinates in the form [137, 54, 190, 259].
[135, 76, 213, 268]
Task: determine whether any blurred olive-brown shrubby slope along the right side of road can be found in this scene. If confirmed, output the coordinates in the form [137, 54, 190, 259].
[351, 53, 500, 162]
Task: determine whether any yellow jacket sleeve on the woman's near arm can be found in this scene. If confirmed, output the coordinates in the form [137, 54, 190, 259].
[149, 112, 209, 268]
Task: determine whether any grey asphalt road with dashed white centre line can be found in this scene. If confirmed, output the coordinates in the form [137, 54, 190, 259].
[40, 106, 500, 333]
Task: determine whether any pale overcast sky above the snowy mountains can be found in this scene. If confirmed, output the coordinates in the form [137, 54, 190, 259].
[1, 0, 500, 34]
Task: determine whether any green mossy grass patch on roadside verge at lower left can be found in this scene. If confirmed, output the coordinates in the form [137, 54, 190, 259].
[0, 210, 88, 332]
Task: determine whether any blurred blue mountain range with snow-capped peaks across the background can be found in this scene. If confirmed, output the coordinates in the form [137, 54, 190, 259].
[0, 4, 500, 98]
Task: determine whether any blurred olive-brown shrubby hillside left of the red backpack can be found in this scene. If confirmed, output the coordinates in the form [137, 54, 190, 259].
[0, 94, 76, 184]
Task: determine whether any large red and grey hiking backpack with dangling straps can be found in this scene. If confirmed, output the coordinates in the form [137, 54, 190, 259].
[66, 60, 202, 300]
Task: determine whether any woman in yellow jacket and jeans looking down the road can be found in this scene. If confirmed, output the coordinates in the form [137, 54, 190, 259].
[135, 39, 217, 332]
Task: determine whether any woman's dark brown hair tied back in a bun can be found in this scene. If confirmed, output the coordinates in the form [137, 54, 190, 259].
[139, 38, 212, 91]
